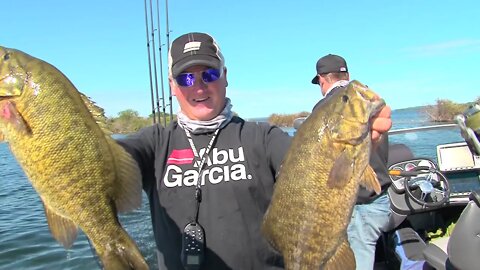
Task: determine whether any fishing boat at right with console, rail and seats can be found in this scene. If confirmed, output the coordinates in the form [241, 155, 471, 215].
[374, 104, 480, 270]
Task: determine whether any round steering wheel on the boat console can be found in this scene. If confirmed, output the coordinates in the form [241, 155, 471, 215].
[404, 166, 450, 208]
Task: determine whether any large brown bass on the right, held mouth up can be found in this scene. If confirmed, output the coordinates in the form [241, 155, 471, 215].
[262, 81, 385, 270]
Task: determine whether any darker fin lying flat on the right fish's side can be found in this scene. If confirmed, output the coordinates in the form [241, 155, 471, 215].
[327, 150, 353, 188]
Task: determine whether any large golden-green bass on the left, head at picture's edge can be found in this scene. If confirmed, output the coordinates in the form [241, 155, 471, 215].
[0, 47, 148, 269]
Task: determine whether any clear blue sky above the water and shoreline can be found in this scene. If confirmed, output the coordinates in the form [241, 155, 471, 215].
[0, 0, 480, 119]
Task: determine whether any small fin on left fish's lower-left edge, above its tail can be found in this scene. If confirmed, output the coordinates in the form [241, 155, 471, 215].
[42, 199, 77, 249]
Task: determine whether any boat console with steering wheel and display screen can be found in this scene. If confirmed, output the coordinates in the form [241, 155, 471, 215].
[388, 142, 480, 215]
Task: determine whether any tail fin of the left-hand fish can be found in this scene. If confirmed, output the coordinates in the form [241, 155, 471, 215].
[98, 230, 149, 270]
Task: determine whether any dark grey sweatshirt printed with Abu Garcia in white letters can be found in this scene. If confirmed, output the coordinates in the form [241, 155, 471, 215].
[118, 117, 290, 269]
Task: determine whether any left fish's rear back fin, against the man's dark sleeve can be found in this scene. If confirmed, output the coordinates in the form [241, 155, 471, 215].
[107, 137, 142, 213]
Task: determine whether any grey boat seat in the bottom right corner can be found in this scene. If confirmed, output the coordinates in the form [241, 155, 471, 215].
[423, 191, 480, 270]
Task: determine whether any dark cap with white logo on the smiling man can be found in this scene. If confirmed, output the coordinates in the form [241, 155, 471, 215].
[168, 33, 225, 77]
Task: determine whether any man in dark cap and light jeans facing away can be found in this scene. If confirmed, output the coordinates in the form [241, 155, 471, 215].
[312, 54, 391, 269]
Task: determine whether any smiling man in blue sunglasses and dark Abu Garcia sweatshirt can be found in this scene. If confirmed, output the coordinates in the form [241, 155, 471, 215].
[120, 33, 391, 269]
